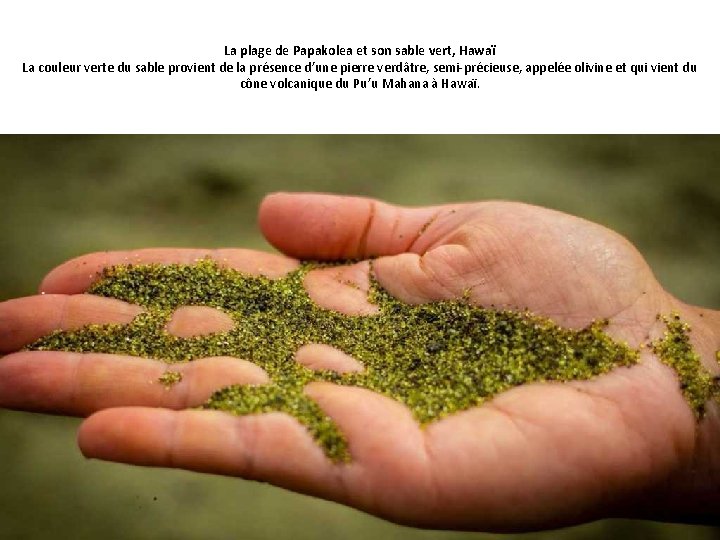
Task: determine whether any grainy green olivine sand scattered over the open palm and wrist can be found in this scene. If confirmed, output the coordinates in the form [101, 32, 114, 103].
[28, 261, 715, 461]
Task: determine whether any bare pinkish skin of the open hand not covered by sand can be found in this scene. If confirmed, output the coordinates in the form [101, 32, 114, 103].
[0, 194, 720, 531]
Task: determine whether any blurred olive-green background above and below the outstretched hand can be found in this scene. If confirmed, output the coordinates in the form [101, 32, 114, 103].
[0, 136, 720, 540]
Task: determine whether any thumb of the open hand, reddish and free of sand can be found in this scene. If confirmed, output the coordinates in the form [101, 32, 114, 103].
[258, 193, 451, 260]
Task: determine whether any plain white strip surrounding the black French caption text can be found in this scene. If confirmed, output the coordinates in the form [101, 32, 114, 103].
[0, 0, 720, 133]
